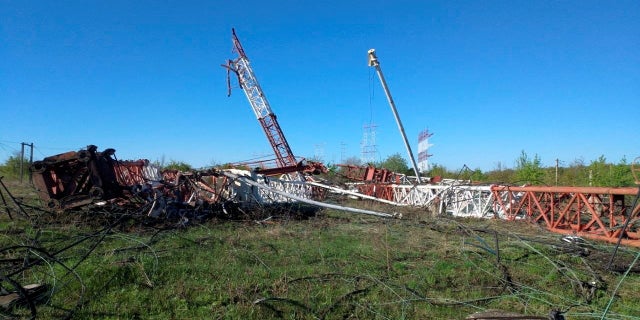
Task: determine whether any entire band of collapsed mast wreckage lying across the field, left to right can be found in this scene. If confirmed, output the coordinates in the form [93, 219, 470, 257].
[22, 145, 640, 246]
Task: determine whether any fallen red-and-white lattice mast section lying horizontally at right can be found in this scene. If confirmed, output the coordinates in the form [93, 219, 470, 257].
[236, 176, 640, 246]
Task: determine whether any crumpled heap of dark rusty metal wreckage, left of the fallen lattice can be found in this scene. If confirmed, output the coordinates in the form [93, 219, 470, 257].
[26, 145, 360, 219]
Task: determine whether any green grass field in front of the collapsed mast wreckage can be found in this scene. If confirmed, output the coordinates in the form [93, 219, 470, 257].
[0, 179, 640, 319]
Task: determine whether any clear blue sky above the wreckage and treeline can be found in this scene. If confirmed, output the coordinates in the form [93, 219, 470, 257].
[0, 0, 640, 170]
